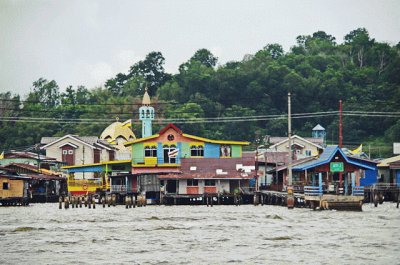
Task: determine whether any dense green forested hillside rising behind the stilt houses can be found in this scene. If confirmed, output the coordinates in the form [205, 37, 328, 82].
[0, 28, 400, 157]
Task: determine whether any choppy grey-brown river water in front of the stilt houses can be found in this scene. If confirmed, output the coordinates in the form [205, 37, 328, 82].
[0, 202, 400, 264]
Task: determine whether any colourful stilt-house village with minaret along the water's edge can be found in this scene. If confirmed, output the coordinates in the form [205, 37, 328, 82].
[0, 90, 400, 211]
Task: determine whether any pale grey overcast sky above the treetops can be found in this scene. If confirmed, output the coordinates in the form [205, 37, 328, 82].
[0, 0, 400, 95]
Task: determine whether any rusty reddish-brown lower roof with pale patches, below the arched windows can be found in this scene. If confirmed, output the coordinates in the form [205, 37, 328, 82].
[159, 157, 256, 179]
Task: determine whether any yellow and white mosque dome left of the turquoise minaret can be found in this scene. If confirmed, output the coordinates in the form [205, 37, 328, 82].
[100, 120, 136, 150]
